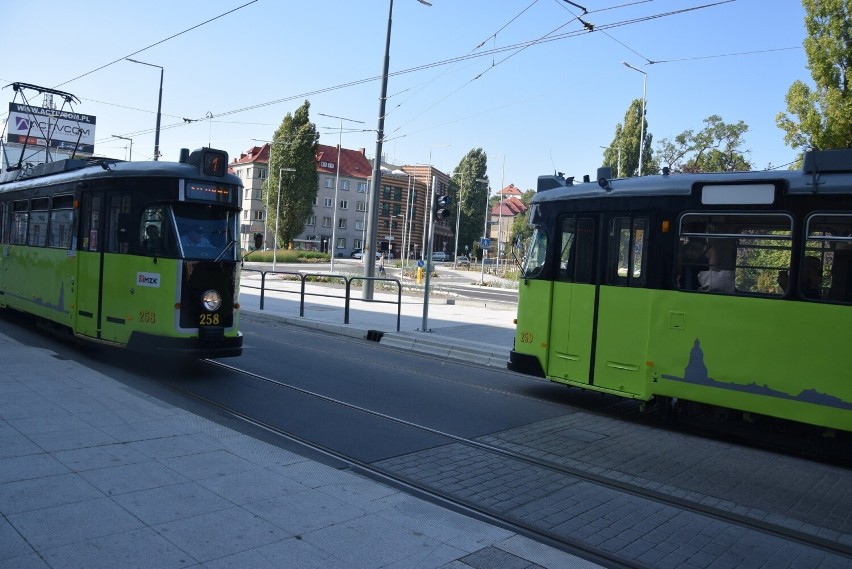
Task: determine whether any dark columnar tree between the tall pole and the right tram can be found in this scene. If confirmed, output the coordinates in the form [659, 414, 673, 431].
[453, 148, 488, 251]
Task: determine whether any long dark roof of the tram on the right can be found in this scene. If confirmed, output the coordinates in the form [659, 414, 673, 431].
[532, 149, 852, 204]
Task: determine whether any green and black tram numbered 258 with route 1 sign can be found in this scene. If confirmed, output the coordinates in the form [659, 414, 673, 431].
[0, 148, 243, 357]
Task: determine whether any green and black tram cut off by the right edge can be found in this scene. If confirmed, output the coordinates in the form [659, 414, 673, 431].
[508, 150, 852, 431]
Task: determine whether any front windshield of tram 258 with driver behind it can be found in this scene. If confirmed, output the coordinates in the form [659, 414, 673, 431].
[172, 203, 237, 260]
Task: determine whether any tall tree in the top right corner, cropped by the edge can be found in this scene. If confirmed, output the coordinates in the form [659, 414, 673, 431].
[775, 0, 852, 150]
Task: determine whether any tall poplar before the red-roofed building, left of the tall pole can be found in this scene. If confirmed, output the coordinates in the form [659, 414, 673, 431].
[266, 101, 319, 247]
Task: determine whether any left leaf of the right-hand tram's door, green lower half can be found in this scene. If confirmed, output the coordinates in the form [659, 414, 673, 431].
[548, 216, 598, 384]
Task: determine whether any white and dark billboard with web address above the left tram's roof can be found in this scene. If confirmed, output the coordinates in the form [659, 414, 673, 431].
[6, 103, 95, 154]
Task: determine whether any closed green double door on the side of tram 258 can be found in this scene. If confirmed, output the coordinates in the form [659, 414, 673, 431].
[76, 192, 134, 343]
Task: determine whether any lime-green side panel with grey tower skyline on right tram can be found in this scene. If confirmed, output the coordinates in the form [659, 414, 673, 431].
[648, 292, 852, 431]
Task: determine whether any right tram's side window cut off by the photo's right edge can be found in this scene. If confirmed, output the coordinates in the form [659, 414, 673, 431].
[798, 213, 852, 303]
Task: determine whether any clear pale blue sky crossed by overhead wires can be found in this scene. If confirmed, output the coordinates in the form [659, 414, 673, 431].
[0, 0, 812, 192]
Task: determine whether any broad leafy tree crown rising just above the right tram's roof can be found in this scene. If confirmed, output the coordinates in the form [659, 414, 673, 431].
[657, 115, 752, 173]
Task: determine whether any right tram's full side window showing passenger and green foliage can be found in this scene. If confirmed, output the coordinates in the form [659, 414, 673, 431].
[677, 213, 793, 296]
